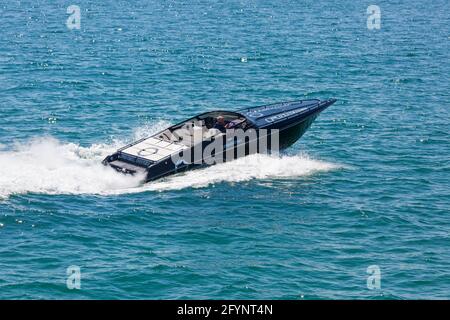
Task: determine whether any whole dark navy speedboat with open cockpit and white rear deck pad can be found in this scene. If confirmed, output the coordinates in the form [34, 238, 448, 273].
[103, 99, 336, 182]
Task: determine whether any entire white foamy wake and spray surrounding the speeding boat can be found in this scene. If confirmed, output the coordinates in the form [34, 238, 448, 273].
[0, 122, 339, 198]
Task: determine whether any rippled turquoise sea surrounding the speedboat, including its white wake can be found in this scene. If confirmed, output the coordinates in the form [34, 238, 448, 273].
[0, 0, 450, 299]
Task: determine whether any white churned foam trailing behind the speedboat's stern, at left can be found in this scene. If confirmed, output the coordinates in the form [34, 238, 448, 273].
[0, 138, 142, 198]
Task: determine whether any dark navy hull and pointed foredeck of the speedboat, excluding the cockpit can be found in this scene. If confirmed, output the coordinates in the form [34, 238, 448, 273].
[103, 99, 336, 182]
